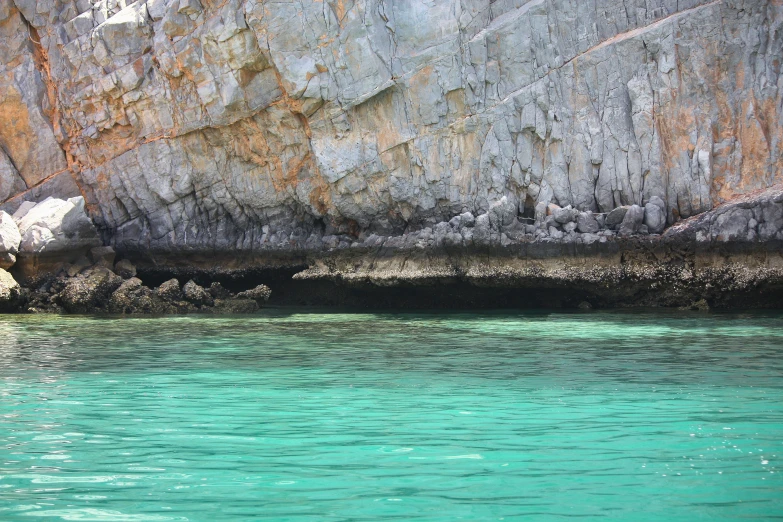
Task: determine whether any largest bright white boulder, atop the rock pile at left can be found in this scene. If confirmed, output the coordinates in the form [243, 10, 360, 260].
[17, 196, 102, 255]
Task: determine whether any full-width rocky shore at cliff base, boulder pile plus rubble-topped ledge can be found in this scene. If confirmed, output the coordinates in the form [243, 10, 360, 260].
[0, 186, 783, 315]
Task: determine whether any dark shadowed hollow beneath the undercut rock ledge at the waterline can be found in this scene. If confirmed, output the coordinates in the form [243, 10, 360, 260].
[138, 265, 783, 310]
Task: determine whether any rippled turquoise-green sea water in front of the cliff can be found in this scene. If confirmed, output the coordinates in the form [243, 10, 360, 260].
[0, 310, 783, 521]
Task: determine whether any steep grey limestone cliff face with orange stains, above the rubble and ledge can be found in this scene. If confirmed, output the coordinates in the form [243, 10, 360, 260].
[0, 0, 783, 255]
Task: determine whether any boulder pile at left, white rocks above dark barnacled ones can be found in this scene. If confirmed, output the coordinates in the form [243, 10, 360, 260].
[0, 192, 271, 315]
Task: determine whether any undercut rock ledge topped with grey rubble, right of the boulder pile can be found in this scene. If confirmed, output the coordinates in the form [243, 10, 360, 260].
[138, 186, 783, 308]
